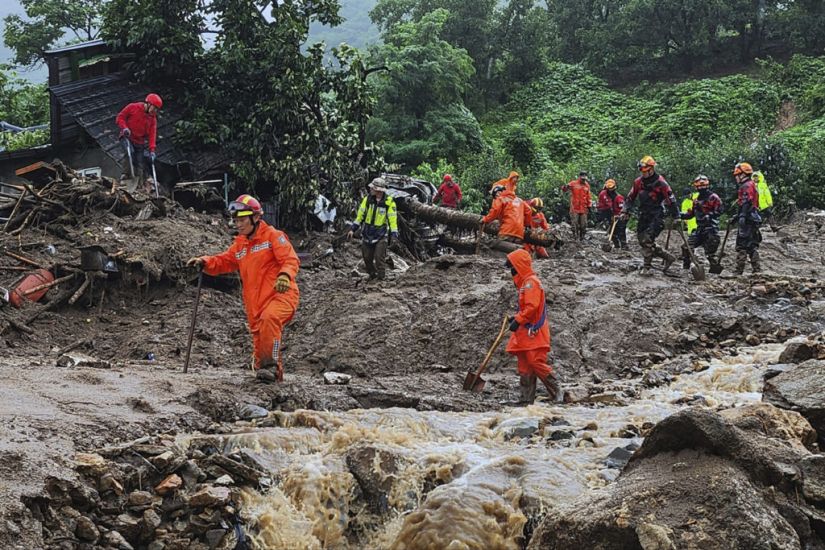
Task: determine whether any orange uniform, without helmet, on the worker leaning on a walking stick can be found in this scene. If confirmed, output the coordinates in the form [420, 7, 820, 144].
[204, 220, 301, 380]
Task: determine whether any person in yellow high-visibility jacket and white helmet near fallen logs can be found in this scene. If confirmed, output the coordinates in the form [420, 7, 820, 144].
[347, 178, 398, 281]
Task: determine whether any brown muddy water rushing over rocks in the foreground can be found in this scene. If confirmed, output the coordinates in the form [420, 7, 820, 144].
[182, 345, 783, 550]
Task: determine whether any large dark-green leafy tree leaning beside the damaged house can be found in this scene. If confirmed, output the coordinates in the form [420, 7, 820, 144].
[104, 0, 383, 224]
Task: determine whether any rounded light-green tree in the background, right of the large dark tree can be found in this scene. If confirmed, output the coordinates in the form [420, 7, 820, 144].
[368, 8, 481, 169]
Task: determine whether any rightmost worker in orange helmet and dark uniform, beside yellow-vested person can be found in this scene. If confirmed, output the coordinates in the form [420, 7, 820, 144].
[731, 162, 762, 275]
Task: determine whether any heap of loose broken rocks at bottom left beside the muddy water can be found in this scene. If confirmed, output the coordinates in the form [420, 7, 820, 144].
[24, 437, 271, 550]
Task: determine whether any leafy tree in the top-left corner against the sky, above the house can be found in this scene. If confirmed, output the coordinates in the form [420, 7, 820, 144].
[3, 0, 107, 66]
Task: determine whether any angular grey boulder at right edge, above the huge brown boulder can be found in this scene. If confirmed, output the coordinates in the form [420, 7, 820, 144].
[762, 359, 825, 449]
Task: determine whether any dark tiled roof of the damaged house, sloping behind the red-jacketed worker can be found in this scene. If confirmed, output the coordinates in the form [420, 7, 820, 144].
[49, 73, 230, 178]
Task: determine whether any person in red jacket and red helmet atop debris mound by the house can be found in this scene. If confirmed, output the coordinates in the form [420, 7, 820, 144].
[115, 93, 163, 193]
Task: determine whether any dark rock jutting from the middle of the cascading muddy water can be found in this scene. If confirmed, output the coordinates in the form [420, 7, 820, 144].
[346, 445, 399, 515]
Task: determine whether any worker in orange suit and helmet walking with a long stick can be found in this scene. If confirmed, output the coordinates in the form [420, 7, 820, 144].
[187, 195, 300, 382]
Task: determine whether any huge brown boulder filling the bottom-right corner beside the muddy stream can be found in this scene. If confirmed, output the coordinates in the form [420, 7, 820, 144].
[528, 405, 825, 550]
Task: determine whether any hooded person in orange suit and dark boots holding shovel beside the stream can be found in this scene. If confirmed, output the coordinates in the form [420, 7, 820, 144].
[506, 249, 559, 403]
